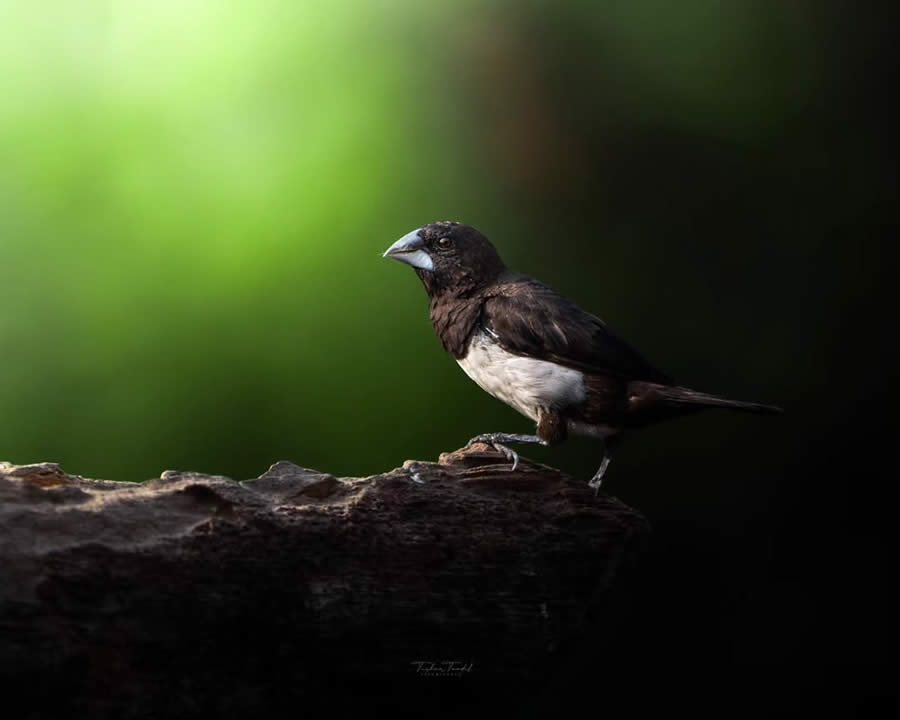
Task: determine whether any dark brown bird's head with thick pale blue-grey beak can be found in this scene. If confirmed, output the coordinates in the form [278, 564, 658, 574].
[384, 222, 505, 295]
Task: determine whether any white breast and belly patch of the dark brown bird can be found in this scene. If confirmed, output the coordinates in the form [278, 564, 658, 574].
[457, 332, 585, 421]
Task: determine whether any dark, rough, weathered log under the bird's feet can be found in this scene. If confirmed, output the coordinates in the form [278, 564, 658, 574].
[0, 446, 648, 718]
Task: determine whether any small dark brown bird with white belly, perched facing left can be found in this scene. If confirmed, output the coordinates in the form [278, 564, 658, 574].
[384, 222, 782, 490]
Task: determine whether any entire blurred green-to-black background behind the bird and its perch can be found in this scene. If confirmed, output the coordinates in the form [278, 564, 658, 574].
[0, 0, 898, 710]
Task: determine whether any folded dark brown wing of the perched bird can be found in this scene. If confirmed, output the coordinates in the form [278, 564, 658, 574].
[481, 277, 671, 384]
